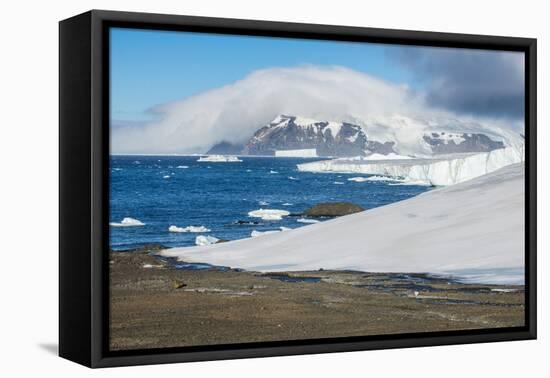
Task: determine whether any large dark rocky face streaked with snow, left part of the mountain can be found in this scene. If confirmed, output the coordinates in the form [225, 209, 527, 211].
[244, 115, 388, 157]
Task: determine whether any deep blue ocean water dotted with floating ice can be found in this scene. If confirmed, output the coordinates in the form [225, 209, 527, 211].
[109, 156, 430, 250]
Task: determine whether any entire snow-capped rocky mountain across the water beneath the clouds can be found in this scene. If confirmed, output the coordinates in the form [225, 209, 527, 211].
[209, 115, 523, 157]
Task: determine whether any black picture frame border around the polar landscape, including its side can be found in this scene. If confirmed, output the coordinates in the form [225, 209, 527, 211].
[59, 10, 537, 367]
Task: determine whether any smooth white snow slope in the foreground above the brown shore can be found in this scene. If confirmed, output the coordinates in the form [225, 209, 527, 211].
[161, 163, 525, 283]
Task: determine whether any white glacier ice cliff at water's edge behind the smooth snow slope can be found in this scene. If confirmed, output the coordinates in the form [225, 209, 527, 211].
[298, 147, 524, 186]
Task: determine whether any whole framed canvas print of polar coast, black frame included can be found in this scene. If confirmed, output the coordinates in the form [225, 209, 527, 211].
[59, 11, 536, 367]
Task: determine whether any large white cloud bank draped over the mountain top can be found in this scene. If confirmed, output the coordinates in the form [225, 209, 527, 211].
[111, 66, 520, 154]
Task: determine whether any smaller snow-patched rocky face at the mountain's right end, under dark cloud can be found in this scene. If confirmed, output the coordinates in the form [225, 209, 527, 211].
[424, 132, 504, 154]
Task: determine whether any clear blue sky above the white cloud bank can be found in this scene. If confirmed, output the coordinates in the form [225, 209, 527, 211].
[111, 28, 423, 122]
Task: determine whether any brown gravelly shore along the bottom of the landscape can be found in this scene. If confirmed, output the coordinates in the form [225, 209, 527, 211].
[109, 246, 525, 350]
